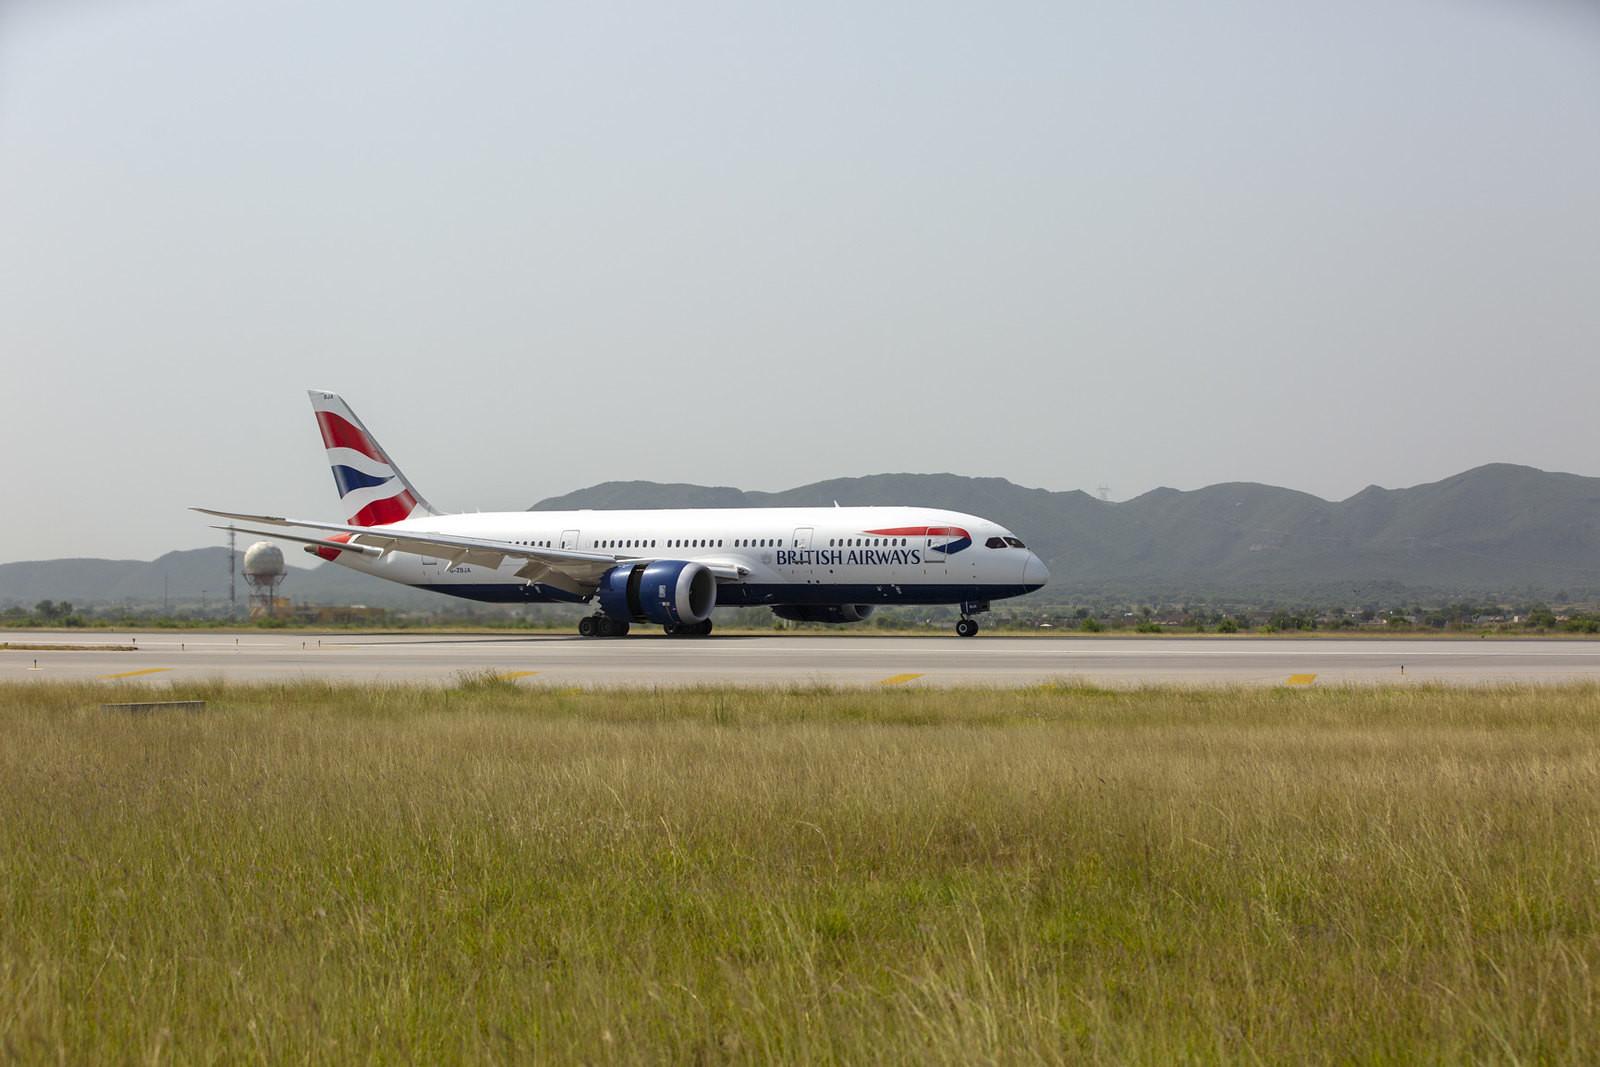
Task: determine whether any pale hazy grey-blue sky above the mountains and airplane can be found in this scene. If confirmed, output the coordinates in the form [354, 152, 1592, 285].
[0, 0, 1600, 561]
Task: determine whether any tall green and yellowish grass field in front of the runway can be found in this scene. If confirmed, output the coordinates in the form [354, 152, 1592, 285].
[0, 677, 1600, 1064]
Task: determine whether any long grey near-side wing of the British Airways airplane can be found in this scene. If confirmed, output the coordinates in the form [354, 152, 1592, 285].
[192, 507, 749, 595]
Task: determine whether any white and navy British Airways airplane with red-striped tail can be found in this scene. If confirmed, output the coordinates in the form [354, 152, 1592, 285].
[192, 389, 1050, 637]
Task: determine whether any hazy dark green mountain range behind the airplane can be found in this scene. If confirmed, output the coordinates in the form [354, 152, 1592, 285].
[0, 464, 1600, 609]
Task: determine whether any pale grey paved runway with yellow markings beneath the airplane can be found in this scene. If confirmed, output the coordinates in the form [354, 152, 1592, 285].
[0, 630, 1600, 688]
